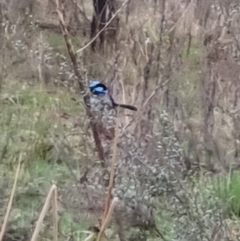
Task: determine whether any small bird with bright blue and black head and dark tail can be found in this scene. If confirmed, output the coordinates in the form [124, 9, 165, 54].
[89, 80, 137, 111]
